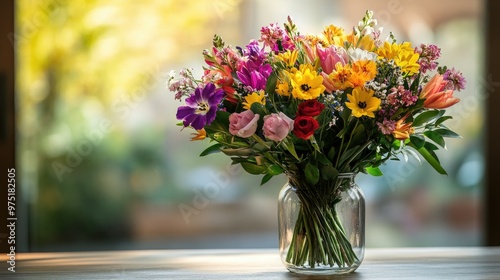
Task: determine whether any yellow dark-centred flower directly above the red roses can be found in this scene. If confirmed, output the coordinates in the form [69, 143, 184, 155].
[290, 64, 325, 100]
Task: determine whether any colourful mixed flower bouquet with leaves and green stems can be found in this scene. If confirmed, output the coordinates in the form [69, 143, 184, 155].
[168, 11, 465, 272]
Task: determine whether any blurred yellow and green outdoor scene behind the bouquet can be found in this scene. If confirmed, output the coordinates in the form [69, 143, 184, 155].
[13, 0, 486, 251]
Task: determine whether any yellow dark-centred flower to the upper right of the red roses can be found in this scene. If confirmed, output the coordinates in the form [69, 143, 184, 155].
[345, 88, 380, 118]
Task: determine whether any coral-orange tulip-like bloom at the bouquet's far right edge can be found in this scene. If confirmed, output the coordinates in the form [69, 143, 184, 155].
[420, 74, 460, 109]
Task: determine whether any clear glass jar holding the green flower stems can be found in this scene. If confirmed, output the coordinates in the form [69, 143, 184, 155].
[278, 173, 365, 275]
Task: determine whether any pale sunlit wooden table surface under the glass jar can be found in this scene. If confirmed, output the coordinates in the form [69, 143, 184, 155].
[0, 247, 500, 280]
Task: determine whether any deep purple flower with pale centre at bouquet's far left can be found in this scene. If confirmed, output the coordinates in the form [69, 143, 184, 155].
[176, 83, 224, 130]
